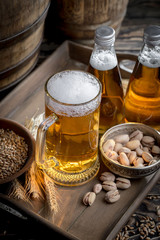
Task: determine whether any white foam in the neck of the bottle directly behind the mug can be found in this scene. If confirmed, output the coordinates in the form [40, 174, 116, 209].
[90, 50, 117, 71]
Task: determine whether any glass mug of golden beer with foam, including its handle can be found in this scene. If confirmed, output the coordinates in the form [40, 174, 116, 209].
[36, 70, 102, 186]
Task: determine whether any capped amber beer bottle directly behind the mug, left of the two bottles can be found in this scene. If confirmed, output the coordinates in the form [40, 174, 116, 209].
[88, 26, 124, 134]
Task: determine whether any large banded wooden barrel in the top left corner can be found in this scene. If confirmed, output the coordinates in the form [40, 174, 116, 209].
[0, 0, 50, 91]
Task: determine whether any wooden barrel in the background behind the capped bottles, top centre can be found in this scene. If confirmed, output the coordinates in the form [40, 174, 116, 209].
[54, 0, 128, 45]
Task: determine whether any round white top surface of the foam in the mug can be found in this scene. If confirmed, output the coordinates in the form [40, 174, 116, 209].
[47, 71, 100, 104]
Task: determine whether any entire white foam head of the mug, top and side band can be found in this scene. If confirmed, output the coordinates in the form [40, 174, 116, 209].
[47, 71, 101, 116]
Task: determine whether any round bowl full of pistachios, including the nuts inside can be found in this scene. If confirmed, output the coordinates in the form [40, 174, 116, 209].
[100, 123, 160, 178]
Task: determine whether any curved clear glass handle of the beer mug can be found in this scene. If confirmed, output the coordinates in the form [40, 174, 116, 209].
[35, 113, 58, 169]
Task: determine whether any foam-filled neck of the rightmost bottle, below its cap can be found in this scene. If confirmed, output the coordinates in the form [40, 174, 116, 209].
[138, 43, 160, 68]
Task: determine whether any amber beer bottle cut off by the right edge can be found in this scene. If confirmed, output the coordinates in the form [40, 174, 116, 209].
[124, 25, 160, 130]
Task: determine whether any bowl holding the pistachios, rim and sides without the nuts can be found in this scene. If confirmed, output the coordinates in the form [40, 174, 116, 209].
[100, 123, 160, 178]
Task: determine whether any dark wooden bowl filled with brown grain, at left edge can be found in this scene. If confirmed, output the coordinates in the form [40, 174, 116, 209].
[0, 118, 35, 184]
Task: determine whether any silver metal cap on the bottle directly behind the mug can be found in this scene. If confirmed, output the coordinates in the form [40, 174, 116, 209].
[94, 26, 115, 46]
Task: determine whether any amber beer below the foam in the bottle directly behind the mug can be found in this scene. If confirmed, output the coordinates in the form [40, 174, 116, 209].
[88, 64, 124, 133]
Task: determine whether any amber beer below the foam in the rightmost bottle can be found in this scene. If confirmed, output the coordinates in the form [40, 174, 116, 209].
[125, 61, 160, 130]
